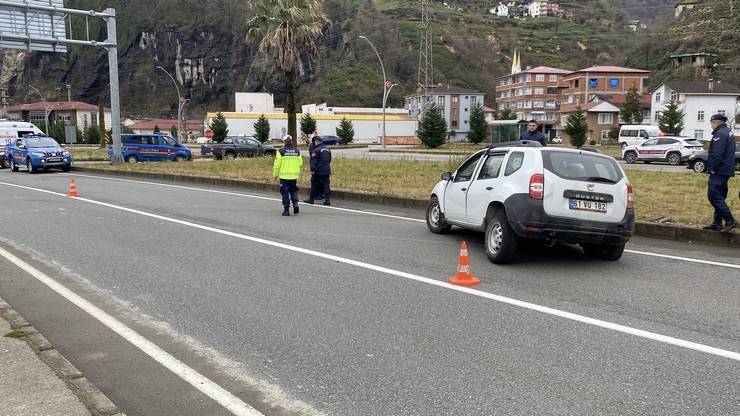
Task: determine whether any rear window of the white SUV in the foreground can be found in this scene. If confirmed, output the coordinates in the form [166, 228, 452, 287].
[542, 150, 624, 183]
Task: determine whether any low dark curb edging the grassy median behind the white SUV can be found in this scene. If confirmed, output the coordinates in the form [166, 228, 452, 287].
[73, 167, 740, 248]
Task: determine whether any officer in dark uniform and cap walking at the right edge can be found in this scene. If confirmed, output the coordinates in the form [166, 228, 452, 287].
[704, 114, 737, 233]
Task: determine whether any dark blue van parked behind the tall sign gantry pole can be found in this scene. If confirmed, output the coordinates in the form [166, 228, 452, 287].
[108, 134, 193, 163]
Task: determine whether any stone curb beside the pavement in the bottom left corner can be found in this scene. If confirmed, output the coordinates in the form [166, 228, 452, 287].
[0, 298, 125, 416]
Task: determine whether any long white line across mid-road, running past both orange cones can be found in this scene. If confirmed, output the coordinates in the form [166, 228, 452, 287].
[5, 182, 740, 361]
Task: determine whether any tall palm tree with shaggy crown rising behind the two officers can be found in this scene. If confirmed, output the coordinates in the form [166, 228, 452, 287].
[247, 0, 329, 140]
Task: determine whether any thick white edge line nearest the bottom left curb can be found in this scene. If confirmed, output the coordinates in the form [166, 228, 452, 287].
[0, 247, 262, 416]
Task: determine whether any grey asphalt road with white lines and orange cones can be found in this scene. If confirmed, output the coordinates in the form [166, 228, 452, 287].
[0, 170, 740, 415]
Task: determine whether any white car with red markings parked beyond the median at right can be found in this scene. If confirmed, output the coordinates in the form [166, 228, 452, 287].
[622, 136, 704, 165]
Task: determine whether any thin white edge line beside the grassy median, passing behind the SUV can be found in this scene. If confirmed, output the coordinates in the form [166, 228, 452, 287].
[67, 174, 740, 269]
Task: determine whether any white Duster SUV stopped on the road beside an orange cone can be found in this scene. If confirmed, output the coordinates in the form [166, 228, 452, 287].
[426, 141, 635, 263]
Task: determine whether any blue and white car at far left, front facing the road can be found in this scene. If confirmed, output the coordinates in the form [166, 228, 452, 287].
[5, 135, 74, 173]
